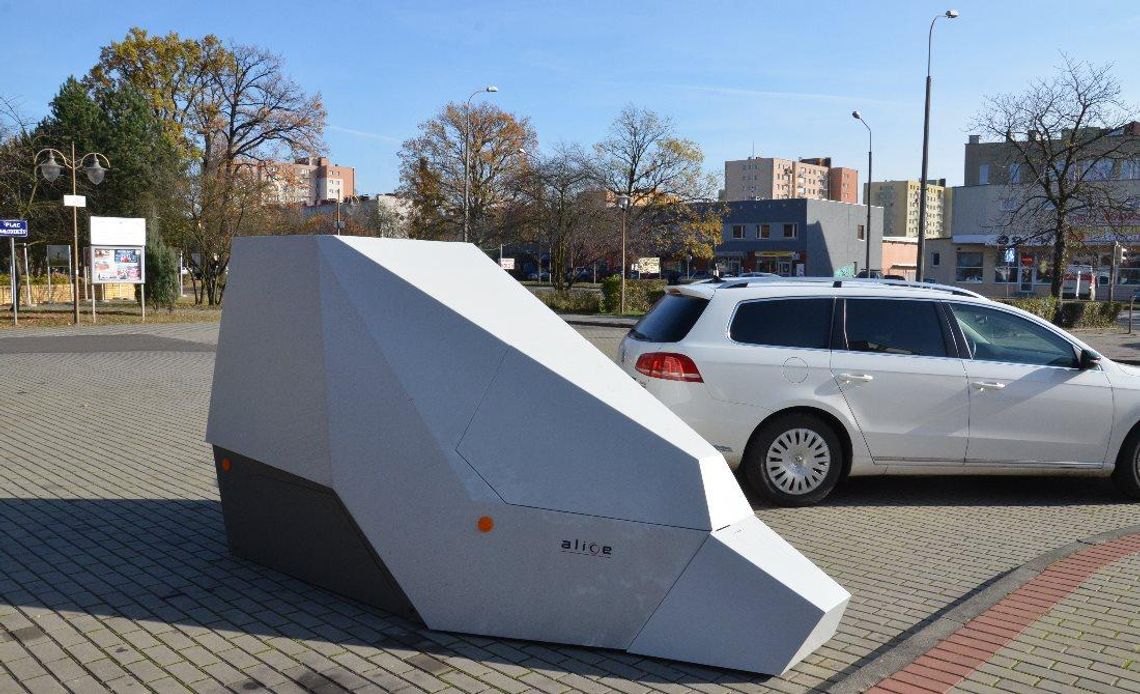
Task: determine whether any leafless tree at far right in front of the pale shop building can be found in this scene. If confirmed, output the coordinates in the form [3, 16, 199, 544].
[972, 56, 1140, 310]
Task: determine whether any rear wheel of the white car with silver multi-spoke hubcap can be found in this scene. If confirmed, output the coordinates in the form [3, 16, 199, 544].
[742, 413, 844, 506]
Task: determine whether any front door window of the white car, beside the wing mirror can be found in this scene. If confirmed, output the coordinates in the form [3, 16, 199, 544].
[950, 303, 1078, 368]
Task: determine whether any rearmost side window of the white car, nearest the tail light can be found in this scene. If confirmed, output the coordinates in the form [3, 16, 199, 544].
[728, 297, 834, 350]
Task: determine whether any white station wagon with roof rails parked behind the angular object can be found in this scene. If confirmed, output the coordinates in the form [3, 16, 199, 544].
[620, 279, 1140, 506]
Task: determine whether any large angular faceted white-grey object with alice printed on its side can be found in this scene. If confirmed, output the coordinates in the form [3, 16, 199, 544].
[206, 236, 849, 673]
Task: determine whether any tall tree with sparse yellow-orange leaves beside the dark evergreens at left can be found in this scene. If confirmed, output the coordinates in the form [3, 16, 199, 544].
[88, 28, 326, 304]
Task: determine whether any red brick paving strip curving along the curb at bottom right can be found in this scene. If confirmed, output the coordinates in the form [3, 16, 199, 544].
[869, 533, 1140, 694]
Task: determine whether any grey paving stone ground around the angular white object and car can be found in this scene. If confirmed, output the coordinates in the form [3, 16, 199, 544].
[0, 324, 1140, 694]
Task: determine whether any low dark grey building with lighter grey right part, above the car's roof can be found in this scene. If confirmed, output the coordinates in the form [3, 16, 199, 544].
[702, 198, 882, 277]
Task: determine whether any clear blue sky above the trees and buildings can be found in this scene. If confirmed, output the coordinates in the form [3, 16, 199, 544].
[0, 0, 1140, 194]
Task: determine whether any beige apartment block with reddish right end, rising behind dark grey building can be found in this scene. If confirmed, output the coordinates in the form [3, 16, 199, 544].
[724, 157, 858, 204]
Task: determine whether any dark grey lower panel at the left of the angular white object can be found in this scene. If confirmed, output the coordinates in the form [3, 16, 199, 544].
[213, 446, 418, 619]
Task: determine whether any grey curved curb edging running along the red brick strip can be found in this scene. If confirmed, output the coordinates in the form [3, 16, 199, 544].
[821, 525, 1140, 694]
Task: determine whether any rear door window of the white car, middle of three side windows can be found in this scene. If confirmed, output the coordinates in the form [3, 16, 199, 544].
[844, 299, 947, 357]
